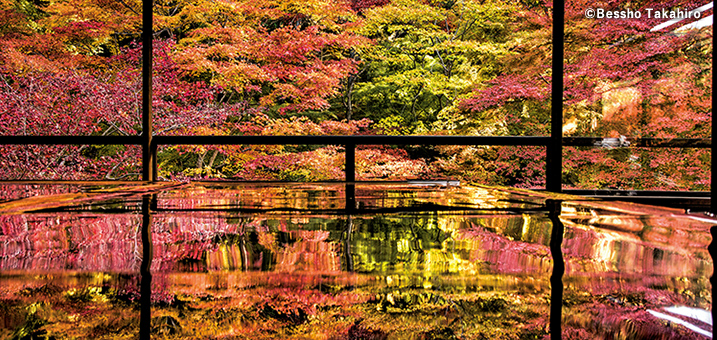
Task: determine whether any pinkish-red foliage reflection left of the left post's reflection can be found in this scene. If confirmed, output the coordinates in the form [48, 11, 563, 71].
[0, 214, 142, 272]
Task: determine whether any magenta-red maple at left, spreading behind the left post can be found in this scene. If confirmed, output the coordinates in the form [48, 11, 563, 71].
[0, 42, 245, 179]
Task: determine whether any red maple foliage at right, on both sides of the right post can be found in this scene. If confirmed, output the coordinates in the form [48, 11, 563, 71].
[454, 1, 712, 190]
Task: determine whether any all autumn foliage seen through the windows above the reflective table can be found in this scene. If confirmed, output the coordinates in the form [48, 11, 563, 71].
[0, 0, 712, 190]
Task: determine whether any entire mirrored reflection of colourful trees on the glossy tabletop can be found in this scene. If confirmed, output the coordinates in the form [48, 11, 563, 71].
[0, 184, 711, 339]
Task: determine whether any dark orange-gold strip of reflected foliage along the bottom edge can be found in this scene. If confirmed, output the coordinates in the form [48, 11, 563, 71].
[7, 273, 708, 340]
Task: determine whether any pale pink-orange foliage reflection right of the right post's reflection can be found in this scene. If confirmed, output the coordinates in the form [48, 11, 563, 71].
[563, 202, 712, 277]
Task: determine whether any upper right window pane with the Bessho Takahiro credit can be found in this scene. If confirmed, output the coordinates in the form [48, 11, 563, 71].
[564, 1, 712, 138]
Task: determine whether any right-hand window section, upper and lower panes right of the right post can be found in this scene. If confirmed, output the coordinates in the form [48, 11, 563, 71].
[563, 0, 712, 190]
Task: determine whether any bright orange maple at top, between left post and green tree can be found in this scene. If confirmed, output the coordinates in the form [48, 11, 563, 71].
[158, 0, 365, 114]
